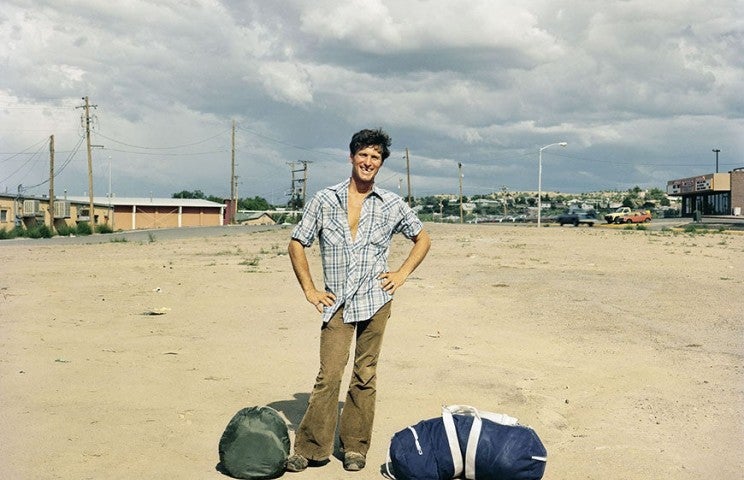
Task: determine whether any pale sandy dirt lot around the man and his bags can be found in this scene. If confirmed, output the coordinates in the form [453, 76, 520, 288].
[0, 224, 744, 480]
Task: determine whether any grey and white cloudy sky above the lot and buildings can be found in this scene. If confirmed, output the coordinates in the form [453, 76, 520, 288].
[0, 0, 744, 204]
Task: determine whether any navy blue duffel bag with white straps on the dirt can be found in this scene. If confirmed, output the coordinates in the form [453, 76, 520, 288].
[387, 405, 547, 480]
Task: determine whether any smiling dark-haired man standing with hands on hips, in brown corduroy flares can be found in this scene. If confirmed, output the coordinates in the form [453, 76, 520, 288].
[287, 130, 431, 472]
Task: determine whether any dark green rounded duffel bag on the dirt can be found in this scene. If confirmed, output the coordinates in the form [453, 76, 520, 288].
[218, 407, 289, 480]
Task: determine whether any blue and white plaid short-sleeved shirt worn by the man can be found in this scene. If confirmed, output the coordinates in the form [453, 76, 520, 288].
[292, 179, 424, 323]
